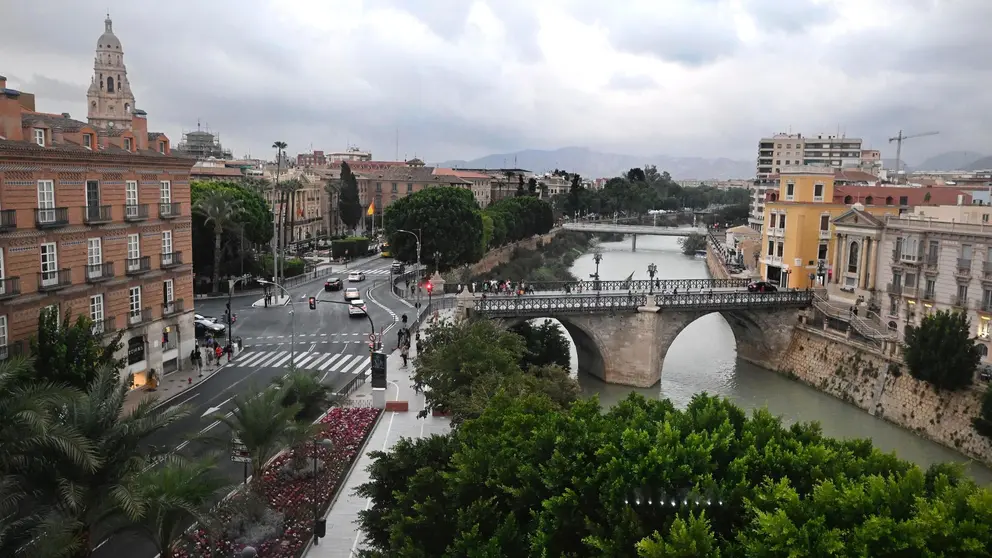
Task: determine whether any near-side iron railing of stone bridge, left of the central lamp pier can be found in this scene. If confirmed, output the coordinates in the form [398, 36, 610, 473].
[475, 294, 647, 318]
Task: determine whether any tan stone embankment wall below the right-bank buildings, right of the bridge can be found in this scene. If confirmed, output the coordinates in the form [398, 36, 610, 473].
[780, 325, 992, 465]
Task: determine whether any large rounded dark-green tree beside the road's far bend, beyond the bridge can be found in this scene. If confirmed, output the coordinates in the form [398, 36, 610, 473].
[383, 186, 483, 271]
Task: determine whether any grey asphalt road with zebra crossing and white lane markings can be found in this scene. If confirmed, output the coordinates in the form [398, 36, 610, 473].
[93, 259, 412, 558]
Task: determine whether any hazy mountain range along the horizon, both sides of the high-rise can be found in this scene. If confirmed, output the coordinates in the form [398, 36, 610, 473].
[438, 147, 992, 180]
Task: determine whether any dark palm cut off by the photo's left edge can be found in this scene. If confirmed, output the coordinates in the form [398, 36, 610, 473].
[0, 358, 100, 556]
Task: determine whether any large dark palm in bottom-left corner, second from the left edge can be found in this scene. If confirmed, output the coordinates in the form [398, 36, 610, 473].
[14, 366, 188, 557]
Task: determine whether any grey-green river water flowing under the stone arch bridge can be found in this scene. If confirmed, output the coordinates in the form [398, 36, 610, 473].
[571, 236, 992, 484]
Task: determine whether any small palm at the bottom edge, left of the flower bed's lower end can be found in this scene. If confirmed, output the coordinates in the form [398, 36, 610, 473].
[134, 456, 228, 558]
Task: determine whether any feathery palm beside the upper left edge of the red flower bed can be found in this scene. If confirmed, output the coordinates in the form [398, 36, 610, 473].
[213, 389, 313, 492]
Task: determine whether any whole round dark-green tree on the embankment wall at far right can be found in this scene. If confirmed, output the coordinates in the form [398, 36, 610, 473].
[903, 310, 982, 390]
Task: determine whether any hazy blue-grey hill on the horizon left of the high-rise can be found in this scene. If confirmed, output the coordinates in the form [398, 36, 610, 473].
[439, 147, 754, 180]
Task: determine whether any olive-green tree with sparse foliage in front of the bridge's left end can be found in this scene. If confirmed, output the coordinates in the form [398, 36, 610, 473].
[413, 320, 578, 423]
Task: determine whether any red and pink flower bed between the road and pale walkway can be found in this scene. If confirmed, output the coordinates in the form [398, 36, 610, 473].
[174, 407, 380, 558]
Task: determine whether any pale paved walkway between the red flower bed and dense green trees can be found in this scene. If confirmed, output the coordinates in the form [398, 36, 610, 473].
[305, 332, 451, 558]
